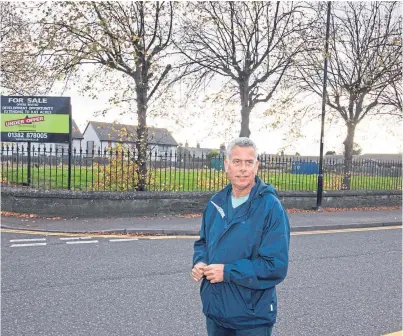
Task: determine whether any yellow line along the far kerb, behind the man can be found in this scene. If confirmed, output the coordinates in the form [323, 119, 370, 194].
[0, 226, 403, 239]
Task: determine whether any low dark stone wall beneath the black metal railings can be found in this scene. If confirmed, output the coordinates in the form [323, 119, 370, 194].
[1, 187, 402, 218]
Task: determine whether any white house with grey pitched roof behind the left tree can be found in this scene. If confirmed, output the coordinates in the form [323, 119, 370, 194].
[83, 121, 178, 155]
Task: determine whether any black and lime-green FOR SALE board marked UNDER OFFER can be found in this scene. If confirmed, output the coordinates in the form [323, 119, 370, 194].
[1, 96, 71, 142]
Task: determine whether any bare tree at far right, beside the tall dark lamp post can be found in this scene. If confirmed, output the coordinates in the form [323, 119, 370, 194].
[295, 2, 402, 189]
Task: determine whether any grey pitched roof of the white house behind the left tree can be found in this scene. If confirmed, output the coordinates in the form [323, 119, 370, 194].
[84, 121, 178, 146]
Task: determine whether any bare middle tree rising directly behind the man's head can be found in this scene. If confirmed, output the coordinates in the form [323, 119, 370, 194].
[175, 1, 308, 137]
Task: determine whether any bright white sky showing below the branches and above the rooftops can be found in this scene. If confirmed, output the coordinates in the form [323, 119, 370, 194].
[64, 89, 402, 155]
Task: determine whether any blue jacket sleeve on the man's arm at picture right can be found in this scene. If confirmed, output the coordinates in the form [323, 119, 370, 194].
[224, 201, 290, 289]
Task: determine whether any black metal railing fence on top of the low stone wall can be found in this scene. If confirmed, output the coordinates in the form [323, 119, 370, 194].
[1, 144, 402, 192]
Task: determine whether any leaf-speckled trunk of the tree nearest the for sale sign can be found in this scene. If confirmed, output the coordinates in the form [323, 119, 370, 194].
[136, 83, 148, 191]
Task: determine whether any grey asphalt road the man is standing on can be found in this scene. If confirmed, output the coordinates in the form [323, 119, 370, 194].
[1, 229, 402, 336]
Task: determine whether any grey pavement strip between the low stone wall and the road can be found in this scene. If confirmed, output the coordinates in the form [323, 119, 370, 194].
[1, 210, 402, 235]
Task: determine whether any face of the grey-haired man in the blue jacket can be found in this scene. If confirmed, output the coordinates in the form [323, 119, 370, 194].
[224, 146, 259, 190]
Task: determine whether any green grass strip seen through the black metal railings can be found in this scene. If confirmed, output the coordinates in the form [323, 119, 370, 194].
[2, 165, 402, 191]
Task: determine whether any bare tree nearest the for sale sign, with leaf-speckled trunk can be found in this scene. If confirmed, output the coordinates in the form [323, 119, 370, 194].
[30, 1, 175, 190]
